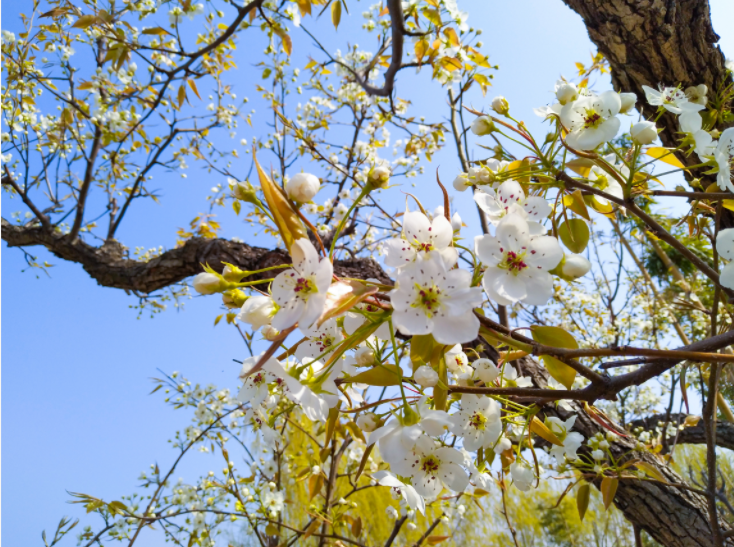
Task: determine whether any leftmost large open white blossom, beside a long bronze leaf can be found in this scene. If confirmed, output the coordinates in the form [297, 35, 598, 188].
[272, 238, 334, 330]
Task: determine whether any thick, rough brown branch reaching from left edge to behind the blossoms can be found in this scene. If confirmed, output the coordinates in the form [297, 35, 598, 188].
[2, 219, 390, 294]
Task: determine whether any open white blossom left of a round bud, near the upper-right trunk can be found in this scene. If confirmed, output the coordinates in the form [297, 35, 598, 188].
[561, 91, 622, 150]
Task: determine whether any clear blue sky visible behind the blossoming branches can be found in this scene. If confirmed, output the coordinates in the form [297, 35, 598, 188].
[2, 0, 734, 545]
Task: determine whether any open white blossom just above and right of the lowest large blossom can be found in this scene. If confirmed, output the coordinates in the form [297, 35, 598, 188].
[451, 395, 502, 451]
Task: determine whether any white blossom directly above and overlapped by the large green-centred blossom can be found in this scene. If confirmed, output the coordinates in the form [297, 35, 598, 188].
[385, 211, 459, 268]
